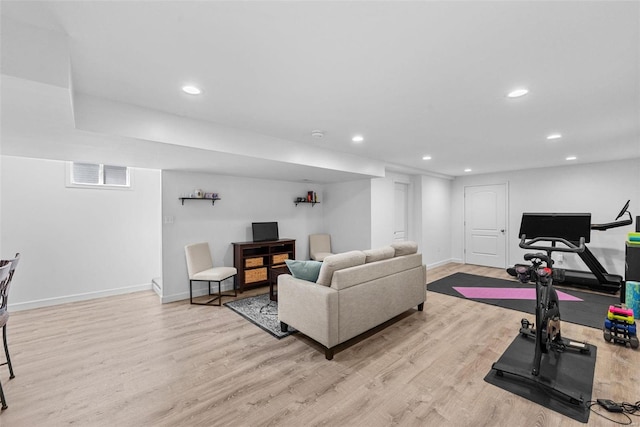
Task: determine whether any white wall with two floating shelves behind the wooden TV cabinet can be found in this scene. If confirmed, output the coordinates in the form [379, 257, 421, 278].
[162, 171, 326, 302]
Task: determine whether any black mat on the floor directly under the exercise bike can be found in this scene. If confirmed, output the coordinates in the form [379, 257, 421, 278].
[484, 334, 597, 423]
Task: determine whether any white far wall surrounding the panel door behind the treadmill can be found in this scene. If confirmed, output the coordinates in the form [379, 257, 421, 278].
[451, 159, 640, 276]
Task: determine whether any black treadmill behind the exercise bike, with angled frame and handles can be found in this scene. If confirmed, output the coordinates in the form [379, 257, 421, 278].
[507, 200, 633, 294]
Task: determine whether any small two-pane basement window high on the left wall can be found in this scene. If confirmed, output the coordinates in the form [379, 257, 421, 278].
[67, 162, 131, 189]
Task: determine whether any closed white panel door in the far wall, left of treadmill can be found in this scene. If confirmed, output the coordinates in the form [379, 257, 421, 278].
[464, 184, 507, 268]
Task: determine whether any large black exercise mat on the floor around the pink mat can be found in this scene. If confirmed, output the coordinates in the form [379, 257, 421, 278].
[427, 273, 620, 329]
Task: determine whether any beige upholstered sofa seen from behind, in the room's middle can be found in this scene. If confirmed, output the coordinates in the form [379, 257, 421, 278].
[278, 242, 426, 360]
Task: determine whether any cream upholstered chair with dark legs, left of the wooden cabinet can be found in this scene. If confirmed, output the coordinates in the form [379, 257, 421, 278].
[184, 242, 238, 306]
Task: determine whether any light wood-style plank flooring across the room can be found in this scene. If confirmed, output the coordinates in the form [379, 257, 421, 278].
[0, 264, 640, 427]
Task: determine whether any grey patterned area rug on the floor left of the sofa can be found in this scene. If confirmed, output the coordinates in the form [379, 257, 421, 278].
[224, 293, 297, 339]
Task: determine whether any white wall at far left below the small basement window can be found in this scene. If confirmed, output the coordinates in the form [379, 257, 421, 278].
[0, 156, 161, 310]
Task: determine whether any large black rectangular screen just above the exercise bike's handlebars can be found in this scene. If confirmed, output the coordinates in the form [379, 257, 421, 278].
[518, 213, 591, 243]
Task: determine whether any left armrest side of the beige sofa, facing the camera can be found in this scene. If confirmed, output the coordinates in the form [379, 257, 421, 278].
[278, 274, 339, 348]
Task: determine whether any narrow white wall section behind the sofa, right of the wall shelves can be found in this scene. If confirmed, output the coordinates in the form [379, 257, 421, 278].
[323, 179, 372, 253]
